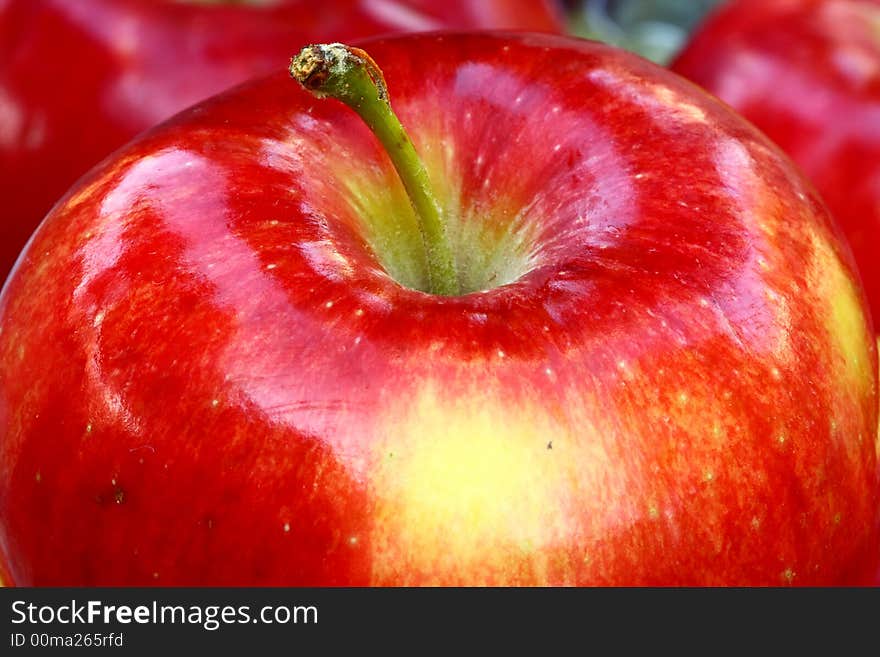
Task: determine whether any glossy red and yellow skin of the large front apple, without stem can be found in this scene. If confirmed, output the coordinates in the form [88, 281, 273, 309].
[0, 34, 880, 586]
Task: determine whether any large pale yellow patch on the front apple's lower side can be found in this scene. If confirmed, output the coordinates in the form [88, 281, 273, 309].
[371, 383, 610, 585]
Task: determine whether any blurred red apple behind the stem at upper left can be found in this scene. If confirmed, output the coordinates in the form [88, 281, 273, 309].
[0, 0, 562, 281]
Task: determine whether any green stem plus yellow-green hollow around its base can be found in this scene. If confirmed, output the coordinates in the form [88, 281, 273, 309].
[290, 43, 531, 296]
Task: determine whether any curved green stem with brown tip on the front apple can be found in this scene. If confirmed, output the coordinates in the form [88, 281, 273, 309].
[290, 43, 461, 296]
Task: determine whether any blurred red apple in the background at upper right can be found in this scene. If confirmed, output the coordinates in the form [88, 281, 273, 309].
[672, 0, 880, 326]
